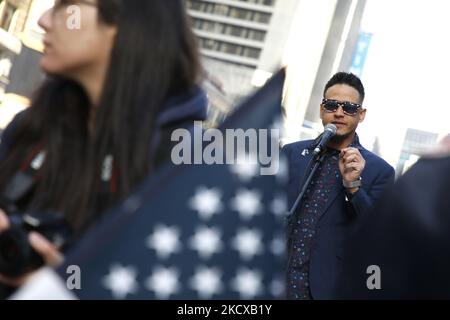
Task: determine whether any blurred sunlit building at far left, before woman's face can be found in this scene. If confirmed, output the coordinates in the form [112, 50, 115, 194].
[0, 0, 48, 129]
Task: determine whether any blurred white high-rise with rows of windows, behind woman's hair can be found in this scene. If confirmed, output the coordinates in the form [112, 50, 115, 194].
[186, 0, 298, 103]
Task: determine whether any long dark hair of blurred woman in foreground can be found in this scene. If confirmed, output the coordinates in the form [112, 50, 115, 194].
[0, 0, 201, 235]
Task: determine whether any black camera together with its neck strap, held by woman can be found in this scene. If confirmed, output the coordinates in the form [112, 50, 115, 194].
[0, 157, 72, 278]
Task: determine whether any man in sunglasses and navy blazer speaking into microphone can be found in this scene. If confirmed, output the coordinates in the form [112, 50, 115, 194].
[282, 72, 395, 299]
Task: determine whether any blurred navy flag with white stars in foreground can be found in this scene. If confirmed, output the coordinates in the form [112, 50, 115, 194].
[58, 70, 287, 300]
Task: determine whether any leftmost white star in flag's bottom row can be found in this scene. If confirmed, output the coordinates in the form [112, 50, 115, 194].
[102, 264, 138, 300]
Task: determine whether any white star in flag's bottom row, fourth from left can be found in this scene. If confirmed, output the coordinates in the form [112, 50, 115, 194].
[231, 269, 263, 300]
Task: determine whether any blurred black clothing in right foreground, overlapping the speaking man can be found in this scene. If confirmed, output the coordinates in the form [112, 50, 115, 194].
[338, 156, 450, 299]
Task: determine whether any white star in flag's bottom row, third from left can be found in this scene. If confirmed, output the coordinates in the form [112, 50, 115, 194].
[191, 267, 223, 299]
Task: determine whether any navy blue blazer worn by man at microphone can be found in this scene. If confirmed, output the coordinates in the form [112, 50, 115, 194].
[282, 140, 395, 299]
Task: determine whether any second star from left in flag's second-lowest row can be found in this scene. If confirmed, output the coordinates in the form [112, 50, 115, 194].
[190, 227, 222, 259]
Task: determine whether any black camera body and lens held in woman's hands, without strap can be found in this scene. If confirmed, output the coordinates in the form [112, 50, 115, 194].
[0, 213, 71, 278]
